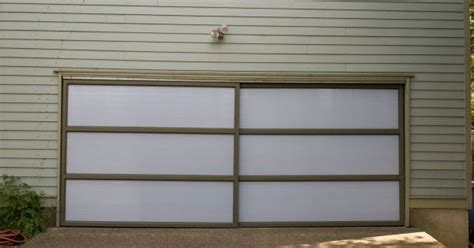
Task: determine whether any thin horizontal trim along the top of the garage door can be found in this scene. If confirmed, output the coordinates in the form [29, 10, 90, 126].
[54, 69, 413, 84]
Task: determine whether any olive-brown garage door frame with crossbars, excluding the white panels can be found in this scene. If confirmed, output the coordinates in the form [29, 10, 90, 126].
[60, 76, 407, 227]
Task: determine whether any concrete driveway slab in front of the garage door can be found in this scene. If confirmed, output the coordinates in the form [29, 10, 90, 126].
[24, 227, 444, 248]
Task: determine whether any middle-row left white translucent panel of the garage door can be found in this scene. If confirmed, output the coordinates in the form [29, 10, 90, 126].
[66, 133, 234, 175]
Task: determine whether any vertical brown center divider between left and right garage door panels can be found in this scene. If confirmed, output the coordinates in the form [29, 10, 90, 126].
[232, 83, 240, 227]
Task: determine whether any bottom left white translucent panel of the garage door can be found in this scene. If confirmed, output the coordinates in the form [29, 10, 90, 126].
[66, 180, 233, 222]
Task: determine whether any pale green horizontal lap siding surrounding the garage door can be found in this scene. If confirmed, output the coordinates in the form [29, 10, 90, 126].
[0, 0, 466, 201]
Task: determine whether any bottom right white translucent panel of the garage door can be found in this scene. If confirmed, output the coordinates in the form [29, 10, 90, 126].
[239, 182, 400, 222]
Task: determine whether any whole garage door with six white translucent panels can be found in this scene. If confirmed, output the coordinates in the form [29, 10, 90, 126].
[61, 79, 404, 227]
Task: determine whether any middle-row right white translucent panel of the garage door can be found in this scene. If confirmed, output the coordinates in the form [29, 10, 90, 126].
[240, 135, 399, 175]
